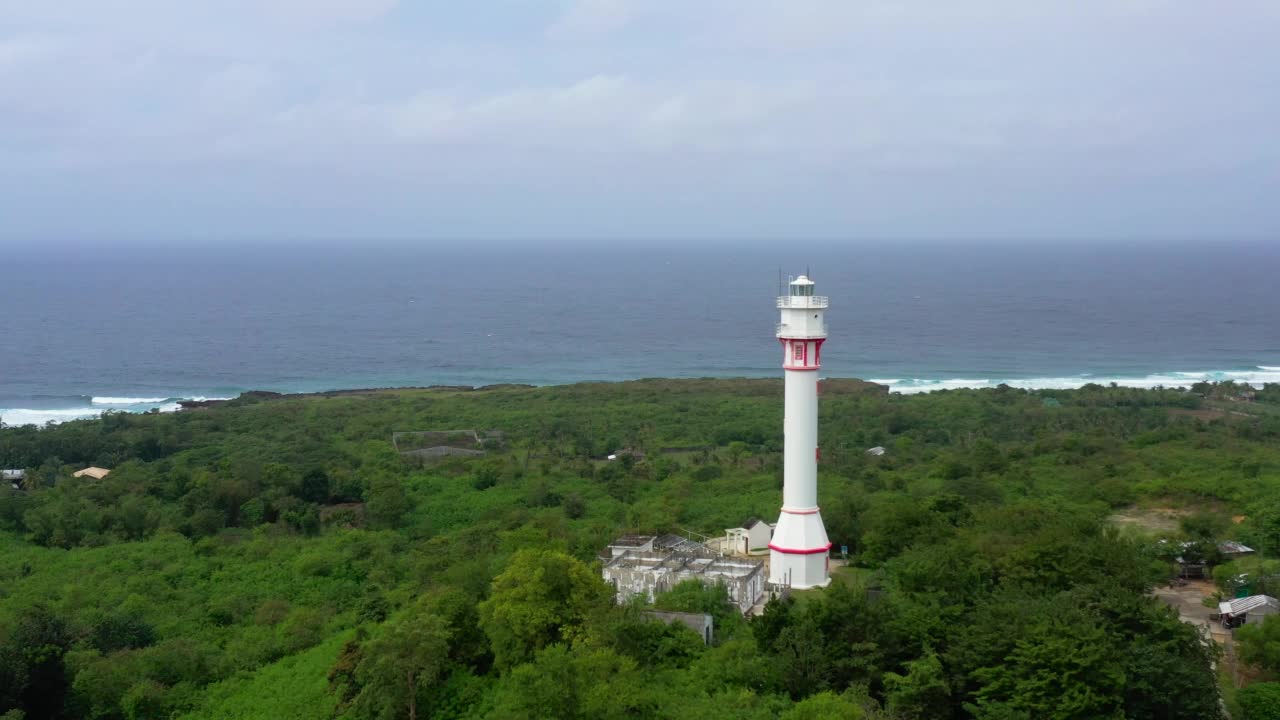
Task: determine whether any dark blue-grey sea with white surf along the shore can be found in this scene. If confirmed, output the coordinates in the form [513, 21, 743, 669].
[0, 241, 1280, 424]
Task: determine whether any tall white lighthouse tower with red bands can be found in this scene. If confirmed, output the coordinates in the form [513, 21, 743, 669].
[769, 275, 831, 589]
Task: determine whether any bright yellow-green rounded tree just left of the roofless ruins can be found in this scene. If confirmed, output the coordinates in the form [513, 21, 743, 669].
[480, 550, 613, 669]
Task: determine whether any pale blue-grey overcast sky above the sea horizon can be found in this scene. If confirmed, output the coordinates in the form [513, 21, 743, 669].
[0, 0, 1280, 243]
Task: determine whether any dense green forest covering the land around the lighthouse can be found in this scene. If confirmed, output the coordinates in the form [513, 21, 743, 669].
[0, 379, 1280, 720]
